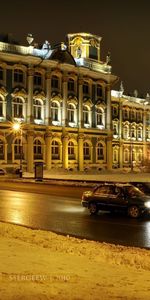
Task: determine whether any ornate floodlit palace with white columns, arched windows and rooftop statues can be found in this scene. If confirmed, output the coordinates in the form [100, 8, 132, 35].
[0, 33, 150, 172]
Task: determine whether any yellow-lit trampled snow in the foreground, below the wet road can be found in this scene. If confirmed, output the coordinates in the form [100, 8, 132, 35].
[0, 223, 150, 300]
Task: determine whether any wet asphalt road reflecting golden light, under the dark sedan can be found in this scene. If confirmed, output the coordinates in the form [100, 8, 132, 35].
[0, 183, 150, 247]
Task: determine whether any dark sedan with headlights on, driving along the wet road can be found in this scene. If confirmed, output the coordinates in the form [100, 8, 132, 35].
[81, 183, 150, 218]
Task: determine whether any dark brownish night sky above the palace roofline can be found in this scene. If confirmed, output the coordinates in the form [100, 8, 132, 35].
[0, 0, 150, 97]
